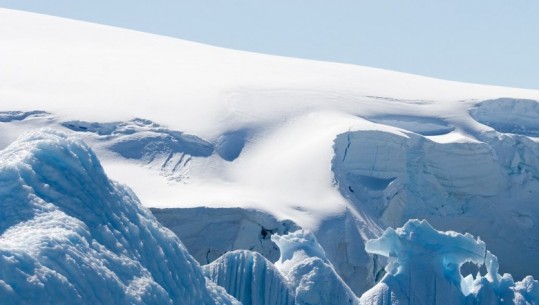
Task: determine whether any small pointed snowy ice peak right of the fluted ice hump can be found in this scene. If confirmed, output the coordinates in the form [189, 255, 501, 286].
[272, 230, 359, 305]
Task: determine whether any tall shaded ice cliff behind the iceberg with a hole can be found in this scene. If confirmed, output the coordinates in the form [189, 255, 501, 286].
[333, 126, 539, 277]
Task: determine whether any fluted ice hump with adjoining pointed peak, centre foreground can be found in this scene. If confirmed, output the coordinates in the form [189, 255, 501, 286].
[207, 230, 359, 305]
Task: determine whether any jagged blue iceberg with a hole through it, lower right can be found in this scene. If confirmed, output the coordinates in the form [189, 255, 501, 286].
[360, 220, 539, 305]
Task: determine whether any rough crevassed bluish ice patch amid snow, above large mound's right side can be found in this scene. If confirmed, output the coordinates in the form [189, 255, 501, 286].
[62, 119, 214, 180]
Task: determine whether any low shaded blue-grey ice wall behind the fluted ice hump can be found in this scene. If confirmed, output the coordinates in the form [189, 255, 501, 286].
[151, 207, 299, 264]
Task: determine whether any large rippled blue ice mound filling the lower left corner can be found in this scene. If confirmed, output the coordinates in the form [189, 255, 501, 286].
[0, 130, 238, 304]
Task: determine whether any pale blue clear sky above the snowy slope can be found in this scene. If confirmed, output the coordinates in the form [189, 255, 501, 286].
[0, 0, 539, 89]
